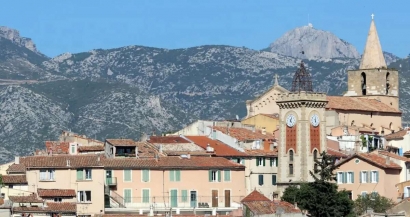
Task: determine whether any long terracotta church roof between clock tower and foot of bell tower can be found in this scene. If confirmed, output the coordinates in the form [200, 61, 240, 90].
[326, 96, 401, 114]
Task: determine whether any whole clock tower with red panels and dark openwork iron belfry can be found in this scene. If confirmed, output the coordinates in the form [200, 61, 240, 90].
[276, 62, 327, 195]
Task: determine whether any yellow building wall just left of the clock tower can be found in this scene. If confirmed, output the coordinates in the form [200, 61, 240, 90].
[241, 114, 279, 133]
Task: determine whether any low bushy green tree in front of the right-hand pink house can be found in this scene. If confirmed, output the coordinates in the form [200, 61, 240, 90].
[354, 192, 394, 215]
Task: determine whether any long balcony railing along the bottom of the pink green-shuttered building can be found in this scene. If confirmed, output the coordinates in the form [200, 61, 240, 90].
[107, 196, 244, 210]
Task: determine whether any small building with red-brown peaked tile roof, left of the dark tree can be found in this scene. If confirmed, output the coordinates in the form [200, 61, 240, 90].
[241, 190, 305, 217]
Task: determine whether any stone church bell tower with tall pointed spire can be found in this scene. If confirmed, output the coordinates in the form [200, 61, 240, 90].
[344, 14, 399, 109]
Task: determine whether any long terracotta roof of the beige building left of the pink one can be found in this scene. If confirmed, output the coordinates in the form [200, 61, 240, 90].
[7, 154, 104, 172]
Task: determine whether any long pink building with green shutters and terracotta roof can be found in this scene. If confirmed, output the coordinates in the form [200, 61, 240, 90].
[104, 155, 246, 214]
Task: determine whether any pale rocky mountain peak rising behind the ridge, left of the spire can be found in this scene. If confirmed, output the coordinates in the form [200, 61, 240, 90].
[268, 23, 360, 59]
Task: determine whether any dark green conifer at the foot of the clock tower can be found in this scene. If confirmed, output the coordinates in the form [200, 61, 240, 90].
[282, 152, 353, 217]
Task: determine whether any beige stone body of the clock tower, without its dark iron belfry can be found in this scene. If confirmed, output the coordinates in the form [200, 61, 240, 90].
[277, 92, 327, 193]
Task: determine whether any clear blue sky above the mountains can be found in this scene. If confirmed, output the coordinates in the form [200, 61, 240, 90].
[0, 0, 410, 57]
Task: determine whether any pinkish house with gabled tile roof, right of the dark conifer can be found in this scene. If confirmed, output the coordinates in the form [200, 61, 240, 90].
[336, 152, 402, 201]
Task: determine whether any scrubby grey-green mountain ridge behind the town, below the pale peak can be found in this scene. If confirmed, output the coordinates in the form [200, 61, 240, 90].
[0, 25, 410, 162]
